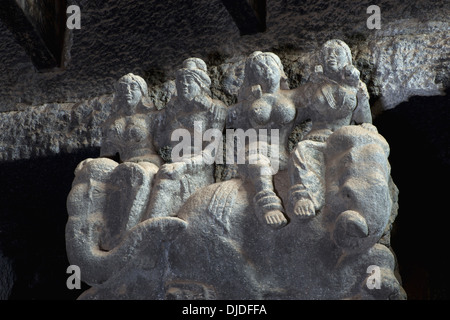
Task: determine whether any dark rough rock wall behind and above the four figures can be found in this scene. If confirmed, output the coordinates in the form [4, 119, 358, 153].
[0, 0, 450, 160]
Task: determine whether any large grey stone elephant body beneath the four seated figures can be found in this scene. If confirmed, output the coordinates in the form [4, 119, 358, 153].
[67, 125, 405, 299]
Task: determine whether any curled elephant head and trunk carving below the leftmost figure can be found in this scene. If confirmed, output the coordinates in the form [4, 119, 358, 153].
[66, 158, 185, 286]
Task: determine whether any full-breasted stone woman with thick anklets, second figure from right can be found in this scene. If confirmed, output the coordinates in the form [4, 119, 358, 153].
[228, 51, 296, 228]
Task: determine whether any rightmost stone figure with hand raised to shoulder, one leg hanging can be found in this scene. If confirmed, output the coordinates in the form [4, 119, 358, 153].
[288, 39, 376, 217]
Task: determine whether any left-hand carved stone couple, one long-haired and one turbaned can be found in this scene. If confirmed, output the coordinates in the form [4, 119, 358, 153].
[68, 58, 226, 250]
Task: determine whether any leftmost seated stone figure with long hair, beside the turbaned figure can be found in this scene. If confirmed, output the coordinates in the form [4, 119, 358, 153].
[71, 73, 162, 250]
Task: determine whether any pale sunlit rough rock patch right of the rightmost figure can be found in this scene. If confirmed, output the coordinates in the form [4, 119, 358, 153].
[366, 32, 450, 110]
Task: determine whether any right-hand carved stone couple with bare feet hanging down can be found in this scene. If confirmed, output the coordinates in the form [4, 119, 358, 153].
[227, 40, 376, 228]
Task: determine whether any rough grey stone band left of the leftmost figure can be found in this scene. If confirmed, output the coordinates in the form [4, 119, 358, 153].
[0, 96, 112, 161]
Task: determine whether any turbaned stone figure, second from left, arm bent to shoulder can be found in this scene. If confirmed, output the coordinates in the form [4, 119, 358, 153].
[147, 58, 226, 217]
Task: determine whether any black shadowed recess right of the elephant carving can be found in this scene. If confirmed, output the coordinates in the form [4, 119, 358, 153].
[374, 88, 450, 300]
